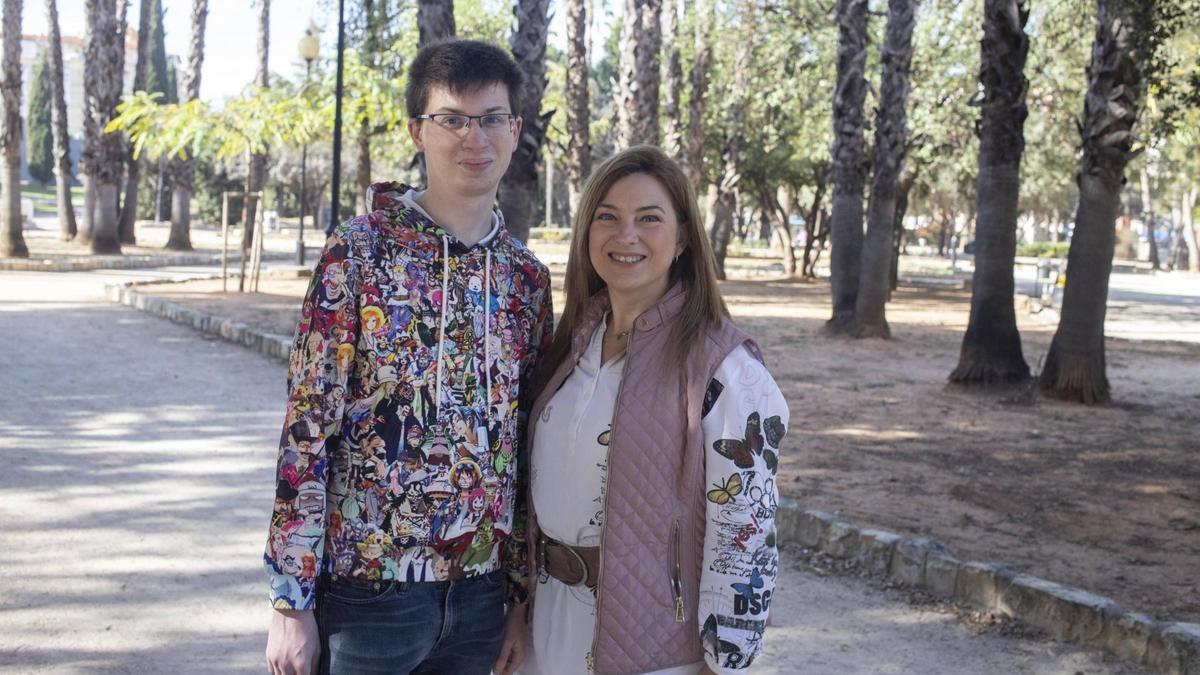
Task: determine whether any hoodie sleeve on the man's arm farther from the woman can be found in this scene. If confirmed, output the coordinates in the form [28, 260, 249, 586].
[263, 221, 361, 609]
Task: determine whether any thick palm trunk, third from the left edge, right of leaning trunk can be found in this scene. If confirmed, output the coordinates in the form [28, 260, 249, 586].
[79, 0, 125, 255]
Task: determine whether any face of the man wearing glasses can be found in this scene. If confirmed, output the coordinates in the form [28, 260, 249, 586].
[408, 84, 521, 197]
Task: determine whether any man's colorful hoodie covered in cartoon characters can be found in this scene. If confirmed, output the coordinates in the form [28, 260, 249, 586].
[264, 183, 553, 609]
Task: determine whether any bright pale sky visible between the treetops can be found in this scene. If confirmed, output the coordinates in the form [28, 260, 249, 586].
[22, 0, 576, 101]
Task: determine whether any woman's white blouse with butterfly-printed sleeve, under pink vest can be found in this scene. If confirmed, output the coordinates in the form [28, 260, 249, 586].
[521, 323, 787, 675]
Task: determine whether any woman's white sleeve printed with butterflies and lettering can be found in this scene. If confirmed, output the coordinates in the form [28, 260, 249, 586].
[697, 348, 787, 674]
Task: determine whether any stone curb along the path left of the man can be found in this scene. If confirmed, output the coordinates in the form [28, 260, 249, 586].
[104, 275, 292, 363]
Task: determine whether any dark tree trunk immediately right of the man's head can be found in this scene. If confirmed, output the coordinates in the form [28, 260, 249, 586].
[499, 0, 550, 241]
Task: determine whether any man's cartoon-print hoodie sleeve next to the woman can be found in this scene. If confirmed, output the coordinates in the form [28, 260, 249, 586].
[505, 268, 554, 605]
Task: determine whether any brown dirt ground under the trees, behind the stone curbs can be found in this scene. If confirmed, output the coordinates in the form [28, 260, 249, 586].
[144, 265, 1200, 621]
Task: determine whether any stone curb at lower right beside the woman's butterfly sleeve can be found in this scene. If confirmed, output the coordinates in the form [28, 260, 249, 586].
[775, 498, 1200, 675]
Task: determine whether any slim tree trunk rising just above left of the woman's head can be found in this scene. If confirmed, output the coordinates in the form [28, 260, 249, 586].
[566, 0, 592, 223]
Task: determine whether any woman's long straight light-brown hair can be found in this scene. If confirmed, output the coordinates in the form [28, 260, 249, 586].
[534, 145, 730, 395]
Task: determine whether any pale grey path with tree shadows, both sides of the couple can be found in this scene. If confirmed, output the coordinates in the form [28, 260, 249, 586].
[0, 269, 1136, 674]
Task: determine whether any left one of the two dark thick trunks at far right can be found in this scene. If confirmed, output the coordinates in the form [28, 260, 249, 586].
[950, 0, 1030, 383]
